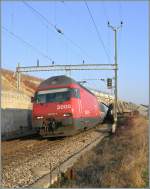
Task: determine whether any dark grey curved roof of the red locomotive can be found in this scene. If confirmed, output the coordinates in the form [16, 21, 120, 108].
[39, 75, 95, 96]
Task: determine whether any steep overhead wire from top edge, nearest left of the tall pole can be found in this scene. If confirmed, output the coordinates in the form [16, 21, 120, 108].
[84, 0, 111, 61]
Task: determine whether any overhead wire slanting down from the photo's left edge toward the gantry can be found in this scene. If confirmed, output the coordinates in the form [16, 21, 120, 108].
[2, 26, 53, 61]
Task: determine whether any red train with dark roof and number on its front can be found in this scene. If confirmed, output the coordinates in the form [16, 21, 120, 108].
[31, 75, 110, 137]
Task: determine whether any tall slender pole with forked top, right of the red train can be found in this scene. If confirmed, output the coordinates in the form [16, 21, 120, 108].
[108, 22, 123, 133]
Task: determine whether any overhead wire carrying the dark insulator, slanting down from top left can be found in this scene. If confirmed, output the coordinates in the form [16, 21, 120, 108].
[22, 1, 96, 63]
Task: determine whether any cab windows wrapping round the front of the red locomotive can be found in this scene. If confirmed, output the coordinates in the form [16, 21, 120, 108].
[35, 88, 80, 103]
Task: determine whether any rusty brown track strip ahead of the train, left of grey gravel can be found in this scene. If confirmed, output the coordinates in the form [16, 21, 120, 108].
[2, 136, 63, 166]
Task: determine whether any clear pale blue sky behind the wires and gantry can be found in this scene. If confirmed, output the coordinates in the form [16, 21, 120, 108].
[2, 1, 149, 104]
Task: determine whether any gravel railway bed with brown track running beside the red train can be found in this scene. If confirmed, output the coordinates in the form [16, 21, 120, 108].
[2, 126, 109, 187]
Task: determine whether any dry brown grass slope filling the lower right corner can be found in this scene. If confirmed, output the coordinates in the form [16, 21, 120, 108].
[61, 117, 148, 187]
